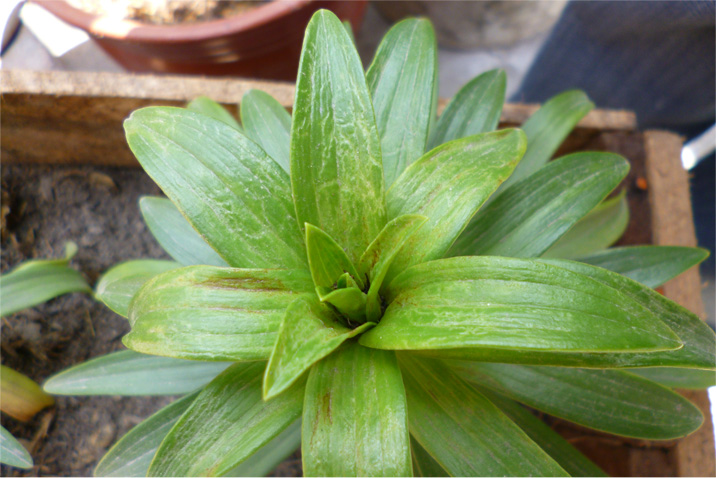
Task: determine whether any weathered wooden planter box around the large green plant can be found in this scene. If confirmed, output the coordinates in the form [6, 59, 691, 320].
[0, 71, 716, 476]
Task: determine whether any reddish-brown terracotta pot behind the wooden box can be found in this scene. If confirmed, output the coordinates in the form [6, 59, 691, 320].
[32, 0, 367, 81]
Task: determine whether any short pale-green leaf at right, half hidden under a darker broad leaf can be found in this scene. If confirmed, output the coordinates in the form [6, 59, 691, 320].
[542, 189, 629, 259]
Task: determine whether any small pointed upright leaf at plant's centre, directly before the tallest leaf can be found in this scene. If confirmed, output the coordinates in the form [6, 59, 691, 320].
[306, 223, 363, 289]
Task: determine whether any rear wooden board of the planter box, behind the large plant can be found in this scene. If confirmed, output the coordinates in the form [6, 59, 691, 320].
[0, 70, 636, 167]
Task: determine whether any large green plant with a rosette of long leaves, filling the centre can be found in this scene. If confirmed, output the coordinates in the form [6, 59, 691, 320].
[45, 11, 716, 476]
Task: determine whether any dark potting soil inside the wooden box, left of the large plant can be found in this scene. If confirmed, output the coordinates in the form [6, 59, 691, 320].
[1, 165, 301, 476]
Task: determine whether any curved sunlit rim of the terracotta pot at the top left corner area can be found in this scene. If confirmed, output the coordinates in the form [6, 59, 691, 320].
[30, 0, 317, 43]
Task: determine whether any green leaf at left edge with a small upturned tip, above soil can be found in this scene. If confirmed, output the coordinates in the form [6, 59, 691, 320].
[0, 242, 92, 317]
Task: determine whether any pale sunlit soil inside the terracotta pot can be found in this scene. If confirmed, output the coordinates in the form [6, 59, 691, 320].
[64, 0, 265, 25]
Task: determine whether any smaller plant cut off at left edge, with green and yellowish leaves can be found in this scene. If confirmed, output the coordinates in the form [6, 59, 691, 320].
[0, 242, 92, 469]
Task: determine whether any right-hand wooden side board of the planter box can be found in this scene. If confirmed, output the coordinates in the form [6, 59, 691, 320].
[644, 131, 716, 476]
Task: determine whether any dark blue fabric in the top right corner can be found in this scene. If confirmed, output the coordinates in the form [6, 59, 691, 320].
[512, 1, 716, 136]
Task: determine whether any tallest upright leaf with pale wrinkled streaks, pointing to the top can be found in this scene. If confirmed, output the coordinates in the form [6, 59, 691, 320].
[291, 10, 386, 262]
